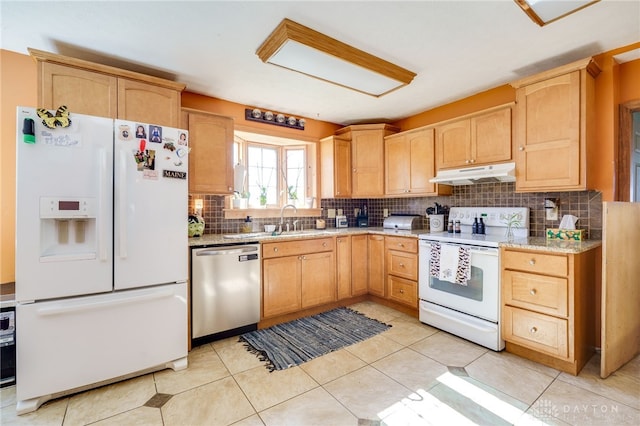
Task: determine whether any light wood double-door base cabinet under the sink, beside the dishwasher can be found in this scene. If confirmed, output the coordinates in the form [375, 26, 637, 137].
[262, 238, 337, 318]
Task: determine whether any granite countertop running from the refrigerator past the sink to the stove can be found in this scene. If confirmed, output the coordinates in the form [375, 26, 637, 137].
[189, 227, 427, 247]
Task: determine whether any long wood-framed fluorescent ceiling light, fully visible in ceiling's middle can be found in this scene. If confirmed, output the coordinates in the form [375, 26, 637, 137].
[256, 19, 416, 97]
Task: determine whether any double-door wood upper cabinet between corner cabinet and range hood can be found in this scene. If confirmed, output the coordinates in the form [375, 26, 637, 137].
[384, 128, 451, 197]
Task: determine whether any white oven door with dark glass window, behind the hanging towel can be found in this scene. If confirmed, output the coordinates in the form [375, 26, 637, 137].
[419, 240, 500, 323]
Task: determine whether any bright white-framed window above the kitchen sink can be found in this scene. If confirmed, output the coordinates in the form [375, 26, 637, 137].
[234, 131, 311, 208]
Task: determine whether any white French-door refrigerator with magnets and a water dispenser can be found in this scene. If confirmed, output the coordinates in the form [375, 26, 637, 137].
[16, 107, 189, 414]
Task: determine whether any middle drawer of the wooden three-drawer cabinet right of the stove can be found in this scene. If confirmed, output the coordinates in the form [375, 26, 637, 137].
[502, 271, 568, 317]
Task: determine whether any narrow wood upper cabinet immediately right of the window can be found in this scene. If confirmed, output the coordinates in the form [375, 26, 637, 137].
[320, 136, 351, 198]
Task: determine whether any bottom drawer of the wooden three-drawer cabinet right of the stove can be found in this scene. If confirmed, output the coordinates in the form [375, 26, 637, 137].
[502, 306, 569, 359]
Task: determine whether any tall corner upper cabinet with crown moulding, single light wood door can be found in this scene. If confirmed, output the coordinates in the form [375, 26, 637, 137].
[335, 124, 400, 198]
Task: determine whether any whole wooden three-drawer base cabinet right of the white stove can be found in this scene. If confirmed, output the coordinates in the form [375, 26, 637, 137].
[501, 248, 600, 375]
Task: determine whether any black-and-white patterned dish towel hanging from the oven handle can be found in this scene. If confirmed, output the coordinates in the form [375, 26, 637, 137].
[429, 243, 471, 285]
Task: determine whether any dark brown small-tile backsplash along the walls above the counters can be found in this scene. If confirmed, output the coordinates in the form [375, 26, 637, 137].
[189, 182, 602, 239]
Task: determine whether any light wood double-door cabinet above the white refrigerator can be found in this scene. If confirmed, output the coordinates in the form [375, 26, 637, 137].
[29, 49, 185, 127]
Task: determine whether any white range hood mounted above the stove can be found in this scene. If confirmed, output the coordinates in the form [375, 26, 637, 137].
[429, 163, 516, 185]
